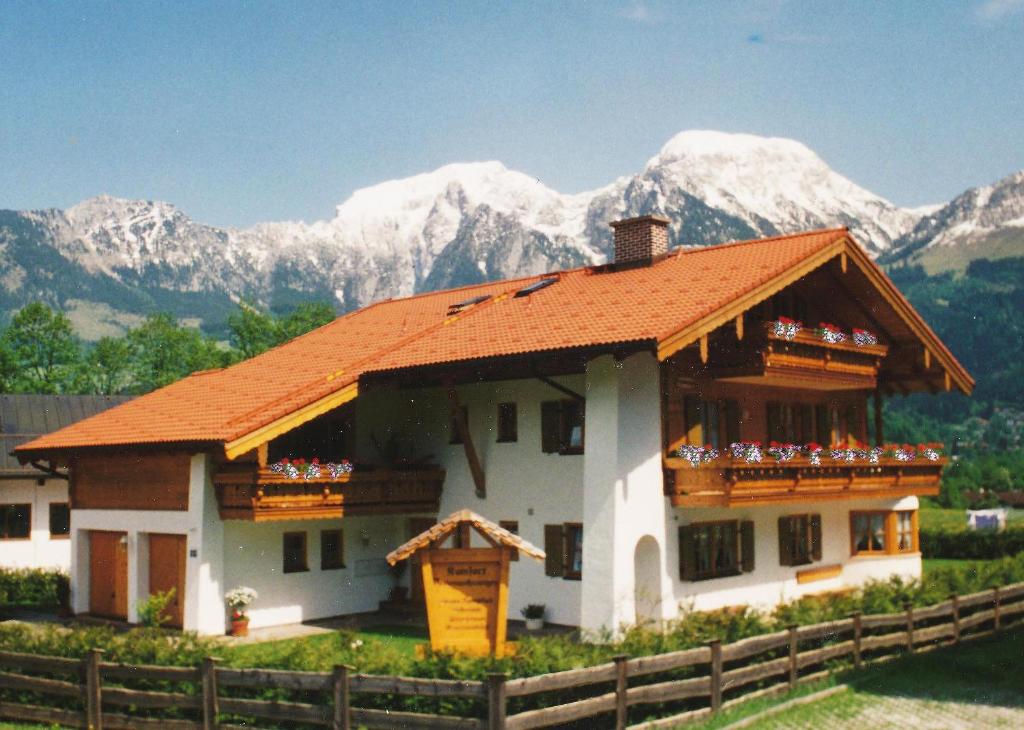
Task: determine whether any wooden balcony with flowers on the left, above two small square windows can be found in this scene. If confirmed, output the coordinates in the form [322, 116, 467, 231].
[213, 464, 444, 522]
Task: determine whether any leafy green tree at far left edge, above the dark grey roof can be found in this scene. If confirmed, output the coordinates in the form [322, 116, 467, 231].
[2, 302, 81, 393]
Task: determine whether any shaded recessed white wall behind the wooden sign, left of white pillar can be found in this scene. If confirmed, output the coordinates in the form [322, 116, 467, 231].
[356, 376, 591, 626]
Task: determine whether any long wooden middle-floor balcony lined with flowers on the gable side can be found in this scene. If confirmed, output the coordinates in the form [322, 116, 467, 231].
[665, 456, 947, 507]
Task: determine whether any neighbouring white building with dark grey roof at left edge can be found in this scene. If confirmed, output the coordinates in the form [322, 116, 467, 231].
[0, 395, 128, 570]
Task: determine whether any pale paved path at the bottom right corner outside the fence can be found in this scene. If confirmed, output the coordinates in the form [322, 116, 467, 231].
[756, 692, 1024, 730]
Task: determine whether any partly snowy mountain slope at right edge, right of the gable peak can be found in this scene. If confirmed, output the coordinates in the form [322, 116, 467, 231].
[886, 170, 1024, 270]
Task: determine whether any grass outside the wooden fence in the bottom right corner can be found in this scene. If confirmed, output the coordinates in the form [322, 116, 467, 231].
[693, 628, 1024, 728]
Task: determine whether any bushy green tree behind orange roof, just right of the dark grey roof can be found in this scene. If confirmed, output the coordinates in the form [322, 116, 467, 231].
[126, 313, 228, 393]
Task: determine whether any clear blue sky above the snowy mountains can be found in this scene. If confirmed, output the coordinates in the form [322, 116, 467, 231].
[0, 0, 1024, 225]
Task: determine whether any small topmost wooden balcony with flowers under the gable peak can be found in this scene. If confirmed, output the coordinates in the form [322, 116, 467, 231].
[714, 324, 889, 390]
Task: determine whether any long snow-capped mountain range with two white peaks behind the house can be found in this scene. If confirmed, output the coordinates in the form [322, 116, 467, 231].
[0, 131, 997, 337]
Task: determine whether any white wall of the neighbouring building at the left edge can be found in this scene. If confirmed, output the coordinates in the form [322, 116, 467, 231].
[0, 479, 71, 570]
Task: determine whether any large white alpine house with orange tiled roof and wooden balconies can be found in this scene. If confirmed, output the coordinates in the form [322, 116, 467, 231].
[16, 216, 974, 634]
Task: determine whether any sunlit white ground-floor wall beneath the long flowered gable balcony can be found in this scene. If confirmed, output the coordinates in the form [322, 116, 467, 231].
[668, 497, 921, 610]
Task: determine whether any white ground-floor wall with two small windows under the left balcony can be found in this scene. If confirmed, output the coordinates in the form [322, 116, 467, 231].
[221, 516, 406, 629]
